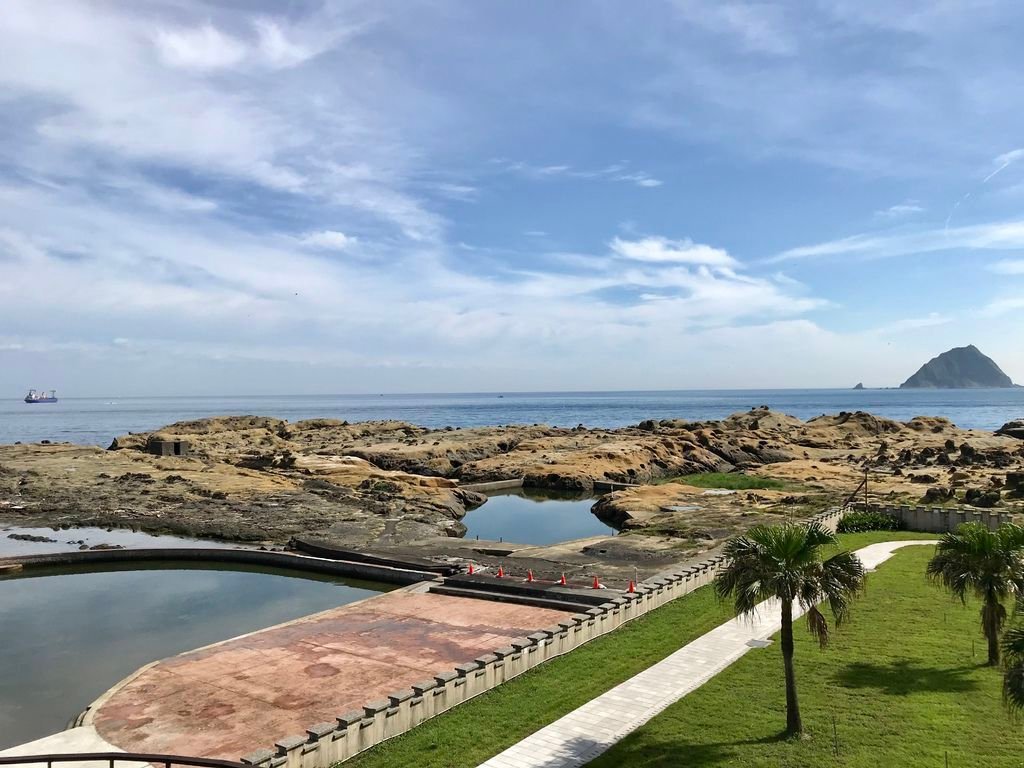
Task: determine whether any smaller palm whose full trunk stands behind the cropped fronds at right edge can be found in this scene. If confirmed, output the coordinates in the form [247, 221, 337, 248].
[928, 522, 1024, 667]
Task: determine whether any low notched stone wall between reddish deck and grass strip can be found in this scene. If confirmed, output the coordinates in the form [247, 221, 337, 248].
[242, 508, 846, 768]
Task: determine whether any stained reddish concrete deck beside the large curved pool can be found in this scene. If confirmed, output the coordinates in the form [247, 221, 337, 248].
[84, 589, 569, 760]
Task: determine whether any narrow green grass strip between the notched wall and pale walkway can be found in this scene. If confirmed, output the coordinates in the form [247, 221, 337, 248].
[345, 531, 929, 768]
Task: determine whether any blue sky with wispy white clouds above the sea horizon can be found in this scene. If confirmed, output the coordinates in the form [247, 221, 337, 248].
[0, 0, 1024, 395]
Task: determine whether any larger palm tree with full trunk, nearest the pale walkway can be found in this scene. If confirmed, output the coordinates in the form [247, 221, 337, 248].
[715, 523, 864, 736]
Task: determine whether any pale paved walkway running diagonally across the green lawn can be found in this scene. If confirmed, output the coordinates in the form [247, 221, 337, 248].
[480, 540, 935, 768]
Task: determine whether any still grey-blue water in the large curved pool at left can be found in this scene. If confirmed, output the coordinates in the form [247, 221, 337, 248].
[0, 561, 391, 750]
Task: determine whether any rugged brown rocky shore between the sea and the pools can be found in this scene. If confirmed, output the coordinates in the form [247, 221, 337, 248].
[0, 408, 1024, 578]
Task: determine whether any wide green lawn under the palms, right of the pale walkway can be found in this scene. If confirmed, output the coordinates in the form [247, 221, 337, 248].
[591, 531, 1024, 768]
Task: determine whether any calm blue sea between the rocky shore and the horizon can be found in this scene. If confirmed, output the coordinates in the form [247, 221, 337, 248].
[0, 389, 1024, 446]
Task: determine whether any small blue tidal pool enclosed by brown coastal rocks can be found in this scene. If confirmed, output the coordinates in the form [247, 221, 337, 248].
[462, 488, 615, 546]
